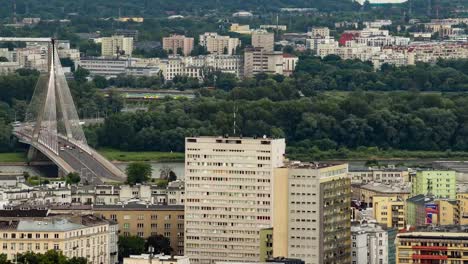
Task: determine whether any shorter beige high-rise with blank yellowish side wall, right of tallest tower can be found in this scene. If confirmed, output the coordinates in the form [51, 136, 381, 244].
[273, 162, 351, 264]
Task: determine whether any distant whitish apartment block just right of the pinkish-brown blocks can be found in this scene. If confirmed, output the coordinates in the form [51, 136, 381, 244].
[200, 32, 240, 55]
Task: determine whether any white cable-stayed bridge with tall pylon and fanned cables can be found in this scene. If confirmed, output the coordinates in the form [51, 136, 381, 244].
[0, 38, 125, 184]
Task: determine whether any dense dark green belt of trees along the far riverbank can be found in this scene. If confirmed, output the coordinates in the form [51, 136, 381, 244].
[88, 88, 468, 156]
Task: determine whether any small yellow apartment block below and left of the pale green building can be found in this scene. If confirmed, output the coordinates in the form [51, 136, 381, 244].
[372, 196, 406, 229]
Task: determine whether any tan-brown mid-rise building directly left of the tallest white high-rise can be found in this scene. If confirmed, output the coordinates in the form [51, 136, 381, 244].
[93, 204, 184, 255]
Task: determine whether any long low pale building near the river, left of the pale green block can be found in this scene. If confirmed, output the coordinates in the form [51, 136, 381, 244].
[349, 168, 409, 184]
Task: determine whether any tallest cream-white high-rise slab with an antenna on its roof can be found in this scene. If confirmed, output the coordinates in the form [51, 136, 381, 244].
[185, 137, 286, 264]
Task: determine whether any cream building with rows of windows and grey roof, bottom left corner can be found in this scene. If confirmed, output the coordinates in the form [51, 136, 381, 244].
[0, 210, 117, 264]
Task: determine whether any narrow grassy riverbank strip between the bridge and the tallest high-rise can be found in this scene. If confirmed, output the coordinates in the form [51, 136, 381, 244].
[98, 148, 184, 162]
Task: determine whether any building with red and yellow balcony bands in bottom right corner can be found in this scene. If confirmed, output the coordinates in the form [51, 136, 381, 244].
[395, 226, 468, 264]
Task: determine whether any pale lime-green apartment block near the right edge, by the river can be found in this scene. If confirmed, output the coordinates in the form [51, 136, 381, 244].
[411, 170, 456, 199]
